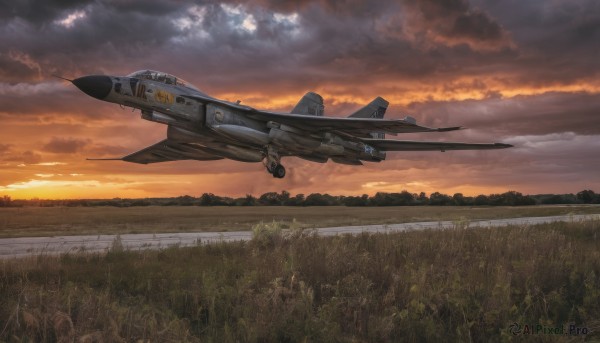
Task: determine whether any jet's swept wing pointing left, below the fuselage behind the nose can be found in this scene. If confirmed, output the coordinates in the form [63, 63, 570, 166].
[88, 139, 223, 164]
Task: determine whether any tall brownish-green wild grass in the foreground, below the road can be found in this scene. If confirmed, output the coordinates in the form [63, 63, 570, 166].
[0, 220, 600, 342]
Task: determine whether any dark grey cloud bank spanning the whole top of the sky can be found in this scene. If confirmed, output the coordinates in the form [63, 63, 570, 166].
[0, 0, 599, 92]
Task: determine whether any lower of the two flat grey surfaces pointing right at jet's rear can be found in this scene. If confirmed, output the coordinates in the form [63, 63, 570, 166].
[362, 139, 512, 151]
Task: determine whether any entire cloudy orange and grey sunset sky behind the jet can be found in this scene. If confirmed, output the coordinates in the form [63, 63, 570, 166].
[0, 0, 600, 198]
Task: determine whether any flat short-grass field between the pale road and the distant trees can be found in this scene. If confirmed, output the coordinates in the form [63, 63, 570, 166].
[0, 206, 600, 237]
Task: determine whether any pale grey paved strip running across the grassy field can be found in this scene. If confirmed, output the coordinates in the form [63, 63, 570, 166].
[0, 214, 600, 259]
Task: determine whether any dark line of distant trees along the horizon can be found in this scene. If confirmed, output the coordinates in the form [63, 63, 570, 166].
[0, 190, 600, 207]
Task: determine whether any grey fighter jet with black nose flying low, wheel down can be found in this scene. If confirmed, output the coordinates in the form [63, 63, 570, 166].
[66, 70, 511, 178]
